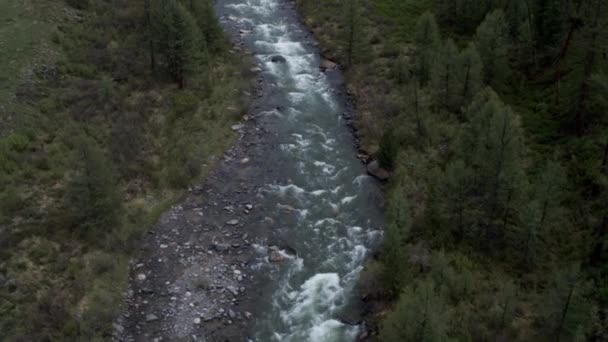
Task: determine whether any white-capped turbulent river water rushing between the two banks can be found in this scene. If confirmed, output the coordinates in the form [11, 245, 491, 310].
[218, 0, 381, 342]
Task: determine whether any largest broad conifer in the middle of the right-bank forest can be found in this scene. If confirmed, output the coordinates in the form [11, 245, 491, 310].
[457, 89, 527, 247]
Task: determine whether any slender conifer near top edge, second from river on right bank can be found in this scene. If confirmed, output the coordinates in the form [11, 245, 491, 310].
[414, 12, 441, 85]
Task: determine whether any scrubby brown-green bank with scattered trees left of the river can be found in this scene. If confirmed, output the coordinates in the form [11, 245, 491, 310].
[0, 0, 249, 341]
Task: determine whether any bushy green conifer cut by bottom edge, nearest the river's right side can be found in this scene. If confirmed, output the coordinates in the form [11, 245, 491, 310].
[379, 280, 450, 342]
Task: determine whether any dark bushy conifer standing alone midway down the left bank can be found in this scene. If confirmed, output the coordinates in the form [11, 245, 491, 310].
[64, 136, 121, 241]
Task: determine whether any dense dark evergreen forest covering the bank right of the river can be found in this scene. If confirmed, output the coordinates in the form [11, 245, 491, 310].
[297, 0, 608, 342]
